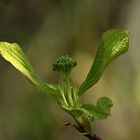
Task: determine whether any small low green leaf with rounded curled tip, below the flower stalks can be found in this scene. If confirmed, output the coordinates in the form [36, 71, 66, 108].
[61, 97, 113, 122]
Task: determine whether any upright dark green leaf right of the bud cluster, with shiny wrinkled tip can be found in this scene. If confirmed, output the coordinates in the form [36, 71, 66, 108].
[78, 29, 129, 95]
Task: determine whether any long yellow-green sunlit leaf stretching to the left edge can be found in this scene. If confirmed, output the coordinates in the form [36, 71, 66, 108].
[0, 42, 58, 98]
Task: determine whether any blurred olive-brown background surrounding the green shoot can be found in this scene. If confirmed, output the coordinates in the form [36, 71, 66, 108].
[0, 0, 140, 140]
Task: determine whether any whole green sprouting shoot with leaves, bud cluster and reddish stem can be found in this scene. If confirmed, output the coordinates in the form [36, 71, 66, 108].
[0, 29, 129, 140]
